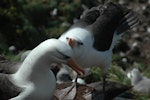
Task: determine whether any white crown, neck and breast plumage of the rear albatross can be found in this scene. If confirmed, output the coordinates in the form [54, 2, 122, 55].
[59, 28, 112, 72]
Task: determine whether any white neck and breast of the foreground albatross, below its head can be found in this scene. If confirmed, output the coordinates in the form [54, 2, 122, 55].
[12, 40, 56, 100]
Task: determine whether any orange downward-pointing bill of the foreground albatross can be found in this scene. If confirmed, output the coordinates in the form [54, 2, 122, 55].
[67, 59, 85, 75]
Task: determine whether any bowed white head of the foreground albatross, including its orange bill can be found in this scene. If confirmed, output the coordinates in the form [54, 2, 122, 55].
[25, 39, 84, 74]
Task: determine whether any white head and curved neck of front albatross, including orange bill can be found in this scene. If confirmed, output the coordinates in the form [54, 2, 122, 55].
[15, 39, 84, 84]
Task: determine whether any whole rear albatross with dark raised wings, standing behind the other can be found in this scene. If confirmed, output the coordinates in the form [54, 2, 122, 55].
[59, 2, 139, 98]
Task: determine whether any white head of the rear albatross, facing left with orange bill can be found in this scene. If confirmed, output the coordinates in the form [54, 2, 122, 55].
[59, 28, 93, 59]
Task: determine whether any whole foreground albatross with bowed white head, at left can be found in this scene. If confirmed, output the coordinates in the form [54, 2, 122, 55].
[0, 39, 84, 100]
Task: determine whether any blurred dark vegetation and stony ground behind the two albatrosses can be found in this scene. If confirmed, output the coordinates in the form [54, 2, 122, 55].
[0, 0, 150, 100]
